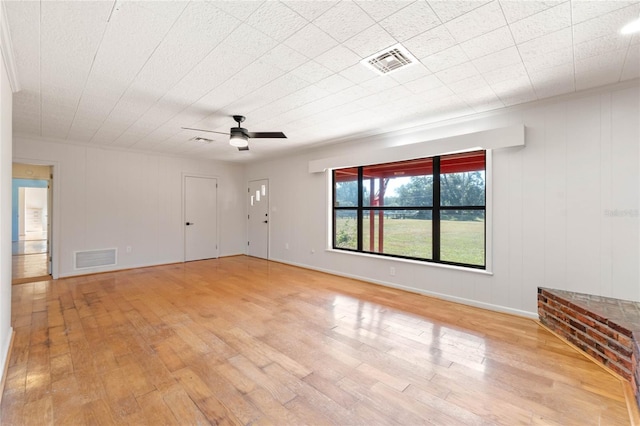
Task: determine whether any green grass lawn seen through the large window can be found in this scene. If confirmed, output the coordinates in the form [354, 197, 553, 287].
[336, 218, 484, 265]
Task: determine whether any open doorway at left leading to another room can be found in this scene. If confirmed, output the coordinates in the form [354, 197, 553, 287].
[11, 163, 52, 284]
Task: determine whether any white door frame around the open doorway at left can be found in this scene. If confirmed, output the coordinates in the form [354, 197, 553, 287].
[12, 157, 61, 280]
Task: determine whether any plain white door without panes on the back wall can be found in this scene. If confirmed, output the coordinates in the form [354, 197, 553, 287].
[184, 176, 218, 262]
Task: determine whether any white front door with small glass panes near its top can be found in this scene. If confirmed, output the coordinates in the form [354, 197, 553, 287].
[248, 179, 269, 259]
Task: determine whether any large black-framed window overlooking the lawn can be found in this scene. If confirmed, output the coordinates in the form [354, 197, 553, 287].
[333, 151, 486, 269]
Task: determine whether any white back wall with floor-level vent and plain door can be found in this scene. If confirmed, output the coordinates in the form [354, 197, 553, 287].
[14, 137, 246, 277]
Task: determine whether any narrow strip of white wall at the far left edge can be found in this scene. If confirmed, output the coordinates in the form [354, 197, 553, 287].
[0, 31, 13, 388]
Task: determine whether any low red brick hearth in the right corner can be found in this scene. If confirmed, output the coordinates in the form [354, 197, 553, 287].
[538, 287, 640, 407]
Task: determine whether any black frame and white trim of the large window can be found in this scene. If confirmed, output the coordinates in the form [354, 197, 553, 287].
[328, 149, 492, 273]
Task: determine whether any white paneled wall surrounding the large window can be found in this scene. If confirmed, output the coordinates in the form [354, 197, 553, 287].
[247, 81, 640, 316]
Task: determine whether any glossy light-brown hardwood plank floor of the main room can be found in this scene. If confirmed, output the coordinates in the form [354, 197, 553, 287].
[0, 257, 629, 425]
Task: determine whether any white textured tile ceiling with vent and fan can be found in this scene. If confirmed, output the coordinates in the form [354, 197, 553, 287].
[4, 0, 640, 161]
